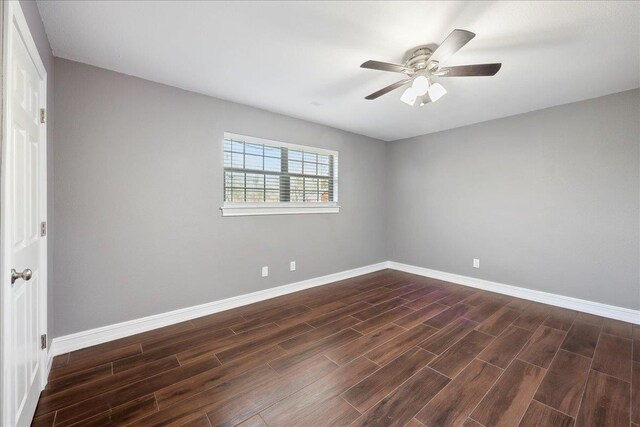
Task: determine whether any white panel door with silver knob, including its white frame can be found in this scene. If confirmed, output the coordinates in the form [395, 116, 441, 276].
[2, 2, 46, 426]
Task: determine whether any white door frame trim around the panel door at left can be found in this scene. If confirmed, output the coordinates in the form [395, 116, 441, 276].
[0, 0, 50, 425]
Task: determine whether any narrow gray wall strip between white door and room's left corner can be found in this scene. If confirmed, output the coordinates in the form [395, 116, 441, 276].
[20, 0, 55, 341]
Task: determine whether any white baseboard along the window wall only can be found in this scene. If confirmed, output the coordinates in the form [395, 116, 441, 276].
[49, 261, 388, 358]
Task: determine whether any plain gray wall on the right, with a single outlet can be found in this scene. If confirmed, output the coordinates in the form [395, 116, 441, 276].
[387, 90, 640, 309]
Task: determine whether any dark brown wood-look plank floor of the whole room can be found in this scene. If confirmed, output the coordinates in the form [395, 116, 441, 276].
[33, 270, 640, 427]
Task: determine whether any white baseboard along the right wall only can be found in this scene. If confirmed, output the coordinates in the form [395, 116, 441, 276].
[388, 261, 640, 325]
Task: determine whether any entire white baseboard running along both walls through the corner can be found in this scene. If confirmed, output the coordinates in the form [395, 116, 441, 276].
[47, 261, 640, 368]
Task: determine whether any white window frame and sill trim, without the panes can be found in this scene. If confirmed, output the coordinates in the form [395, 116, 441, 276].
[220, 132, 340, 216]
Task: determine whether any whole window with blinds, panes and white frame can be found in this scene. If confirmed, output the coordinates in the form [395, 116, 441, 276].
[222, 132, 339, 216]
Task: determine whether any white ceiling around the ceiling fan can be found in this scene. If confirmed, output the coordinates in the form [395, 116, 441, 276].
[38, 1, 640, 140]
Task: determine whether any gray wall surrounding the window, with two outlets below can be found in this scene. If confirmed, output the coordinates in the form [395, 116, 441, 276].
[53, 58, 386, 336]
